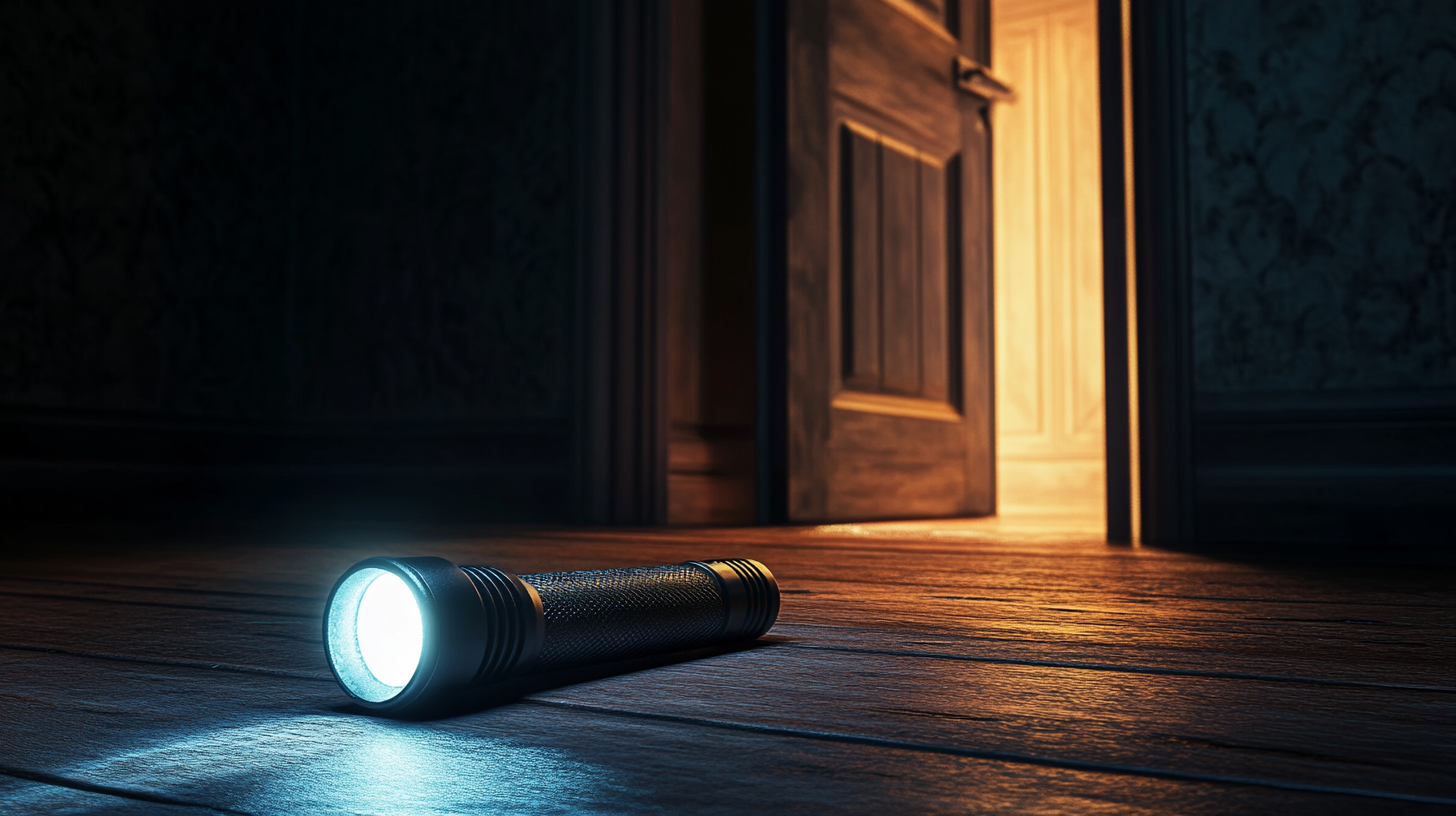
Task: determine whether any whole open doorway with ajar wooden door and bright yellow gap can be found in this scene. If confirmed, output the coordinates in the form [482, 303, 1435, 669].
[655, 0, 1117, 526]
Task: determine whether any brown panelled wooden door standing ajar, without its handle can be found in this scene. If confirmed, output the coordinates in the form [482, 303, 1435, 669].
[783, 0, 996, 522]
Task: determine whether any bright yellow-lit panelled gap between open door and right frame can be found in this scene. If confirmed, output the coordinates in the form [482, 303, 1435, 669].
[990, 0, 1107, 519]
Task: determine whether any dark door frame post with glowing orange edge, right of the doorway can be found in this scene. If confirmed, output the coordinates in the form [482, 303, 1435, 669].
[1098, 0, 1194, 544]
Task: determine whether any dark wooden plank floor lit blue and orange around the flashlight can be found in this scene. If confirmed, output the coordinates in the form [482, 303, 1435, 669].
[0, 520, 1456, 815]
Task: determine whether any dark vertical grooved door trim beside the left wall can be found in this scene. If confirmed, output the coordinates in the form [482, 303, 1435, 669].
[574, 0, 670, 525]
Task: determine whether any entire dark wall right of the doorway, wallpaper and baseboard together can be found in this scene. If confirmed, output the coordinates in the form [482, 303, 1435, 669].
[1185, 0, 1456, 546]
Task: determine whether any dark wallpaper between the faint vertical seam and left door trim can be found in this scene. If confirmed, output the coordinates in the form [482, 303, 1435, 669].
[293, 0, 577, 418]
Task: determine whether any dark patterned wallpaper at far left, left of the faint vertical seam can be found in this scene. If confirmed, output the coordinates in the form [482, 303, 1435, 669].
[0, 0, 288, 417]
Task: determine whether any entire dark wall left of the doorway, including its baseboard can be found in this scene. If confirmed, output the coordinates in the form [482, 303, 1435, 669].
[0, 0, 581, 519]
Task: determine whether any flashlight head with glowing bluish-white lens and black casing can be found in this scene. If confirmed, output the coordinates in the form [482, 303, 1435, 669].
[323, 558, 486, 711]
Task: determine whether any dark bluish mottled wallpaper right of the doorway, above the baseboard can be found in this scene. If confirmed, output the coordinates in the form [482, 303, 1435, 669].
[1187, 0, 1456, 392]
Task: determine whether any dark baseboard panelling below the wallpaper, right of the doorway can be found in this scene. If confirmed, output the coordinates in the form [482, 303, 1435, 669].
[1194, 391, 1456, 549]
